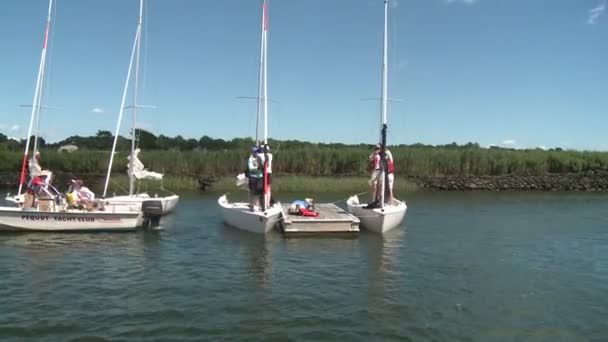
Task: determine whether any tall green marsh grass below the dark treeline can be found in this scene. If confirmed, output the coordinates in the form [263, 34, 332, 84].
[0, 145, 608, 180]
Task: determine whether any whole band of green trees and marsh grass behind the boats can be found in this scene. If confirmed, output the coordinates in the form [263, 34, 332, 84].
[0, 130, 608, 183]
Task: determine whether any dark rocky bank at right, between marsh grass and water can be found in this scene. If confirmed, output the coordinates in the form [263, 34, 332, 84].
[407, 171, 608, 191]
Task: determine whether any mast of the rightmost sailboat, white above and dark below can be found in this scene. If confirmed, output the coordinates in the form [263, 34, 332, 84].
[380, 0, 388, 208]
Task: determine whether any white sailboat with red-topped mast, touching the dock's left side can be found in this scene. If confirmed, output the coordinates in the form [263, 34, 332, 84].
[217, 0, 282, 234]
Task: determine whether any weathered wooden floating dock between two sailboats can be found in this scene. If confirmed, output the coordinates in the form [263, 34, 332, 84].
[282, 203, 359, 234]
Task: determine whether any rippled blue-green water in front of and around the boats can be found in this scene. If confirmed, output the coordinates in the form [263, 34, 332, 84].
[0, 193, 608, 341]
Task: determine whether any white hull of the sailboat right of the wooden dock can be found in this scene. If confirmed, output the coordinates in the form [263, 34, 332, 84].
[346, 195, 407, 233]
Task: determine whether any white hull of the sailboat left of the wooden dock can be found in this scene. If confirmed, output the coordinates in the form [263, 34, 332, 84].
[217, 195, 282, 234]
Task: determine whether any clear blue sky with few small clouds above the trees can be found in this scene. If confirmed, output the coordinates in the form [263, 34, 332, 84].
[0, 0, 608, 150]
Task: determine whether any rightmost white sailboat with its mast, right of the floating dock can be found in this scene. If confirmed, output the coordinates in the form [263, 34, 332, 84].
[346, 0, 407, 233]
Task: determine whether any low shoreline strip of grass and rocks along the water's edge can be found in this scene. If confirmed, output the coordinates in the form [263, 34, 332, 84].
[0, 171, 608, 194]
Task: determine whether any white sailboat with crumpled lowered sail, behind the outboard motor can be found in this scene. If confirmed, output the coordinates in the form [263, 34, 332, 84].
[103, 0, 179, 215]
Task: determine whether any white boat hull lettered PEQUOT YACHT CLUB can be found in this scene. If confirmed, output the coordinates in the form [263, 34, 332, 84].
[0, 207, 143, 232]
